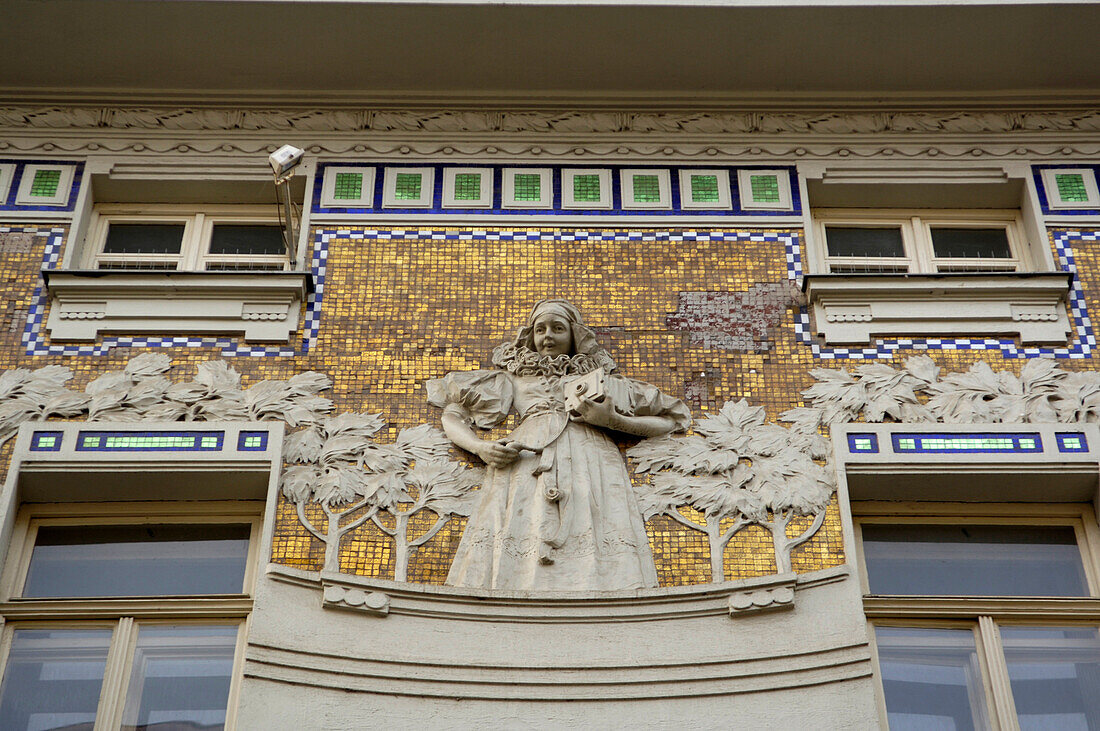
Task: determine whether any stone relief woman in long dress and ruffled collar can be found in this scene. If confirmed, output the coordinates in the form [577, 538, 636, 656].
[427, 300, 691, 591]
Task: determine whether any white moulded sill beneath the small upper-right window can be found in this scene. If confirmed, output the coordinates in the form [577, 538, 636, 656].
[803, 272, 1071, 344]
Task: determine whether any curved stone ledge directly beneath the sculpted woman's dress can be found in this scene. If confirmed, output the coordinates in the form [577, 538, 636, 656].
[267, 564, 849, 623]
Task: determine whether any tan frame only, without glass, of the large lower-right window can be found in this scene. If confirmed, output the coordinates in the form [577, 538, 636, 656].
[850, 500, 1100, 729]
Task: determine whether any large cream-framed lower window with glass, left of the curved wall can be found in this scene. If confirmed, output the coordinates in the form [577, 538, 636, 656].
[0, 502, 260, 731]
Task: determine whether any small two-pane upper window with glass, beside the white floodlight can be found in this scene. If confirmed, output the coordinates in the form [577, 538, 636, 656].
[87, 206, 289, 272]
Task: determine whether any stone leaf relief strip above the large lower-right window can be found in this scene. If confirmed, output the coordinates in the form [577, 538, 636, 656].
[780, 355, 1100, 429]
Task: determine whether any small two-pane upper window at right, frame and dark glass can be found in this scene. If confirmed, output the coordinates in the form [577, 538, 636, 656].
[814, 209, 1033, 274]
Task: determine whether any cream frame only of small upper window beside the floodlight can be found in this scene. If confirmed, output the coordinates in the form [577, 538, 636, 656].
[81, 203, 294, 274]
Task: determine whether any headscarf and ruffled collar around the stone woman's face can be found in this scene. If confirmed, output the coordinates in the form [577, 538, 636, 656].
[493, 299, 615, 376]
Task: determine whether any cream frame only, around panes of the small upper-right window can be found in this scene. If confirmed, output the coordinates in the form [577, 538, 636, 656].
[812, 208, 1037, 275]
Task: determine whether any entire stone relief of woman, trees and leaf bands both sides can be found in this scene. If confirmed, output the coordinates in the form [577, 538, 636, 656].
[8, 351, 1100, 590]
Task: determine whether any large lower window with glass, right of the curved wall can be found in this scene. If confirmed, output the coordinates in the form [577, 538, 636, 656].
[853, 502, 1100, 731]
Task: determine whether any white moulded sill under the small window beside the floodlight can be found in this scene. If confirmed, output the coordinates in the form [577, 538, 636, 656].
[43, 270, 310, 343]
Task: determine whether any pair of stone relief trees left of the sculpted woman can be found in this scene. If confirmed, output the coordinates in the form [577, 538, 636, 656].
[283, 413, 481, 582]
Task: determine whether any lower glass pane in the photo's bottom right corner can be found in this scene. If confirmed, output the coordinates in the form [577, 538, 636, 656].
[1001, 627, 1100, 731]
